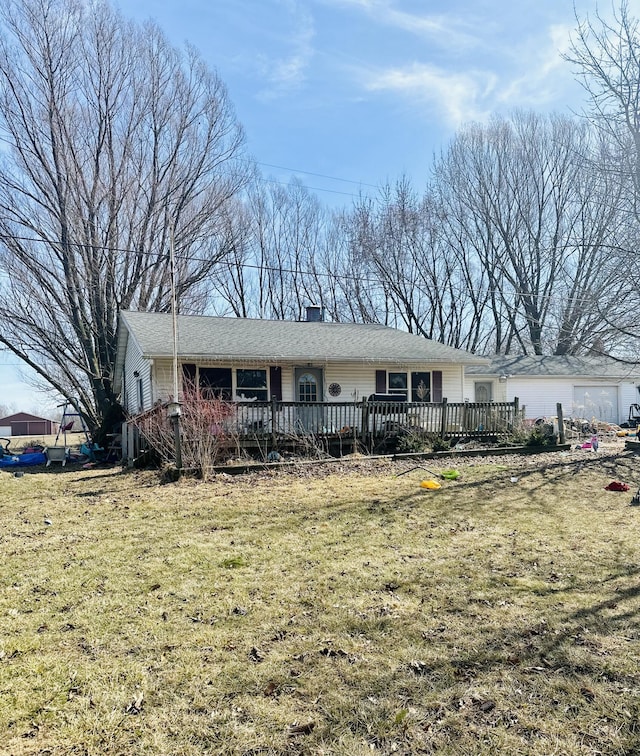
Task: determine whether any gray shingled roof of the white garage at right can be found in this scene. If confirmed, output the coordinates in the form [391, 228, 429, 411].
[466, 355, 640, 380]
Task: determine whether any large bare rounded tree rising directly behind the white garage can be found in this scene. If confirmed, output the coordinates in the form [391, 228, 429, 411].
[436, 113, 623, 354]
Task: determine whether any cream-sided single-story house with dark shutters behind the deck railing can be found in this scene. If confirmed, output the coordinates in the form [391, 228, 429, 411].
[113, 308, 487, 415]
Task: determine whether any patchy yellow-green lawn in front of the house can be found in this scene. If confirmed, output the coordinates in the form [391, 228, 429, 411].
[0, 452, 640, 756]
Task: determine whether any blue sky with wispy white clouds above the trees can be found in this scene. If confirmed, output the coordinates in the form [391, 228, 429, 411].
[0, 0, 616, 410]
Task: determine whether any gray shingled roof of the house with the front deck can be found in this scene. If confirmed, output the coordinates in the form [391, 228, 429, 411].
[119, 312, 487, 365]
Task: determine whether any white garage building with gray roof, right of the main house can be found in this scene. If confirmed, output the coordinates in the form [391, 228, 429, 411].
[464, 355, 640, 424]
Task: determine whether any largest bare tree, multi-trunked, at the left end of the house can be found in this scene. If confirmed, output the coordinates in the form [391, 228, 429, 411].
[0, 0, 246, 430]
